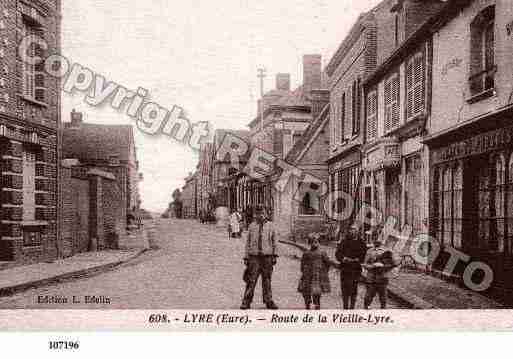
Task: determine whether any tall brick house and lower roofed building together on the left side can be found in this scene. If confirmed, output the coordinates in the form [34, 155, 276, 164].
[0, 0, 140, 268]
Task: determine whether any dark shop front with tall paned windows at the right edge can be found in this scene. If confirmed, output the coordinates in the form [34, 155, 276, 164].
[429, 121, 513, 298]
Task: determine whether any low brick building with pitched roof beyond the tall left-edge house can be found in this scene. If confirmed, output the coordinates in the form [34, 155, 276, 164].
[62, 111, 141, 244]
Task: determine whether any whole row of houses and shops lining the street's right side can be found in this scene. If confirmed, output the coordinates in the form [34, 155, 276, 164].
[182, 0, 513, 296]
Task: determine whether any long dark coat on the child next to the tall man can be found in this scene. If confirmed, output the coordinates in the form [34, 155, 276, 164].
[297, 249, 331, 295]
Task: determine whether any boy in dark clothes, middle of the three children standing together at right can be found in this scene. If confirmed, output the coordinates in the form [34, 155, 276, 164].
[335, 223, 367, 309]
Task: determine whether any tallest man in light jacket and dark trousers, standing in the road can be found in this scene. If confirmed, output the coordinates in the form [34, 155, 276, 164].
[240, 208, 278, 309]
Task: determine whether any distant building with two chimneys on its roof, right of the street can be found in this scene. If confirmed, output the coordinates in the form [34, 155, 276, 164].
[232, 54, 325, 219]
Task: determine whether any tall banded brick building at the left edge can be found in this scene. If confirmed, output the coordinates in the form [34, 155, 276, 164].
[0, 0, 61, 264]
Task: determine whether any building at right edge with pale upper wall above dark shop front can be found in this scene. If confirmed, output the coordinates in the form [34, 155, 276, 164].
[424, 0, 513, 297]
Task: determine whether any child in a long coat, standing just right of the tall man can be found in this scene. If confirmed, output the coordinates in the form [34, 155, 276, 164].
[298, 238, 332, 310]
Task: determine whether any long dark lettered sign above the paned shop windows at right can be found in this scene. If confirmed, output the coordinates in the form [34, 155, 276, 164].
[433, 127, 513, 163]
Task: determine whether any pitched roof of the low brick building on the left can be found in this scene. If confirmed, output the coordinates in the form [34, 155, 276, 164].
[62, 123, 134, 161]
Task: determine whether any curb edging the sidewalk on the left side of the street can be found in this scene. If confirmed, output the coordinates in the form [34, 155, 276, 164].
[0, 249, 148, 298]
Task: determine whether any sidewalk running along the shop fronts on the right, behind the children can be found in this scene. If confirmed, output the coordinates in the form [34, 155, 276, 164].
[280, 241, 504, 309]
